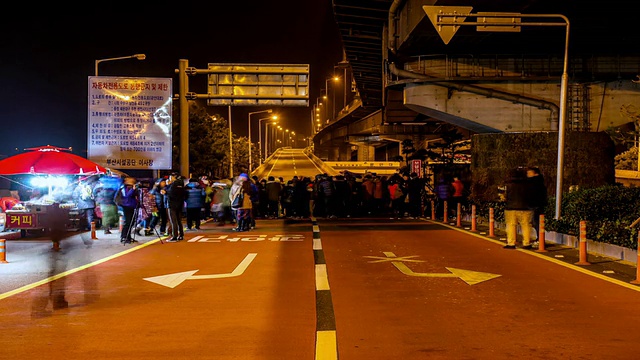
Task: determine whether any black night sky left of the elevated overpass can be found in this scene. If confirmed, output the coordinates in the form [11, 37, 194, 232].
[0, 0, 342, 158]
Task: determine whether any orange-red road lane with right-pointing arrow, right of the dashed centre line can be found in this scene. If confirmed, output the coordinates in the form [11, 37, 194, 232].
[321, 221, 640, 358]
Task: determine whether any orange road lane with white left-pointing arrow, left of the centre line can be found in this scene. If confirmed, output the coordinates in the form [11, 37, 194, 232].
[0, 226, 315, 360]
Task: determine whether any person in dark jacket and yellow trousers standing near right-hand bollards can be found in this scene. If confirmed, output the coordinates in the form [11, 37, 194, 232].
[504, 168, 533, 249]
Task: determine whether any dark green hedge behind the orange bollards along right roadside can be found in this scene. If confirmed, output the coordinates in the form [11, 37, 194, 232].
[471, 184, 640, 249]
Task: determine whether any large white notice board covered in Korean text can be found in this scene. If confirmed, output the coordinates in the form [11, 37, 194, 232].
[87, 76, 172, 170]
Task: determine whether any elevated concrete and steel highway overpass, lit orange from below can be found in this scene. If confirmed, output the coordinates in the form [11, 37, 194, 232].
[313, 0, 640, 161]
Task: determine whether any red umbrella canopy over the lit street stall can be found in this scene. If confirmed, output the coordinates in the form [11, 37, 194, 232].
[0, 145, 107, 175]
